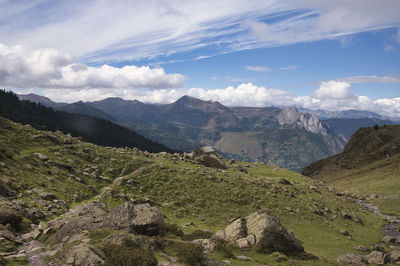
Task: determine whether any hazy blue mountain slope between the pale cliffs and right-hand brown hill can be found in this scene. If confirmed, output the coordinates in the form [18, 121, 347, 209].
[324, 118, 393, 139]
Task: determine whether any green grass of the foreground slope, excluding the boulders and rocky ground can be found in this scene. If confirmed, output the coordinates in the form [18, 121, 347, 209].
[0, 118, 383, 265]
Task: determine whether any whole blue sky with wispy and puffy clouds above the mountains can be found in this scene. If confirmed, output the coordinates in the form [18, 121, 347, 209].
[0, 0, 400, 117]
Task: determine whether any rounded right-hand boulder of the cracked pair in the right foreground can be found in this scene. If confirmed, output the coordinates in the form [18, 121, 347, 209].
[246, 211, 304, 252]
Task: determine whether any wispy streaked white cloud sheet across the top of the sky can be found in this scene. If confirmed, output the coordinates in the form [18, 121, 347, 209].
[0, 0, 400, 62]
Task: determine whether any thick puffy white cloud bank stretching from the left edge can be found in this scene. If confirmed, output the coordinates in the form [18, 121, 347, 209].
[0, 44, 185, 89]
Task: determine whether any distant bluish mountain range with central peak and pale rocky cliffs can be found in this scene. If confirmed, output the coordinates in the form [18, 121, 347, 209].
[87, 96, 345, 171]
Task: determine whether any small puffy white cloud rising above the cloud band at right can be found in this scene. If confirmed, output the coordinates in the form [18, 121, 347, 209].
[314, 80, 356, 100]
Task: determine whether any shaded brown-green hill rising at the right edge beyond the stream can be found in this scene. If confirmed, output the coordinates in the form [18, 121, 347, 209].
[302, 125, 400, 215]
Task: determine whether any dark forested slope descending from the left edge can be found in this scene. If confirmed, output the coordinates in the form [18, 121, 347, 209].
[0, 90, 172, 152]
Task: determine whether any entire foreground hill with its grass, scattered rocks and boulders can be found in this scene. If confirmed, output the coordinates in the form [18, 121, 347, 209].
[0, 118, 390, 265]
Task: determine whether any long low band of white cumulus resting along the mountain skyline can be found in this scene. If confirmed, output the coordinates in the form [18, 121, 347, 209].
[36, 81, 400, 117]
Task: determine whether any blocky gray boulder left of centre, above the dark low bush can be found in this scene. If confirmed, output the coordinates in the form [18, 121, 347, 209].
[108, 202, 164, 235]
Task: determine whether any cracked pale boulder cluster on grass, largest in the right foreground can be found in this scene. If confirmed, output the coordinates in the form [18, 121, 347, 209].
[213, 211, 304, 252]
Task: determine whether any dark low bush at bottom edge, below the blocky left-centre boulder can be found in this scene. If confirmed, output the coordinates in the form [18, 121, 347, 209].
[101, 243, 158, 266]
